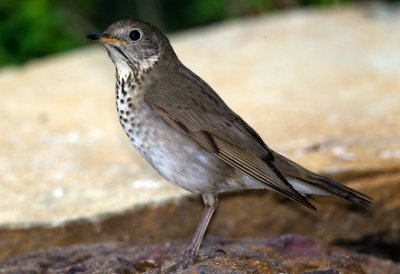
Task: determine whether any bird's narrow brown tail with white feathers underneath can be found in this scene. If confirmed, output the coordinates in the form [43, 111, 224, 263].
[272, 151, 372, 209]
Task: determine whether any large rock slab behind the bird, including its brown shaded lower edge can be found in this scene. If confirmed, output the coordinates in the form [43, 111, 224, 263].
[0, 4, 400, 261]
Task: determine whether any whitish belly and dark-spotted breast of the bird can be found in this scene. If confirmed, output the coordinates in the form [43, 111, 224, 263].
[117, 86, 230, 193]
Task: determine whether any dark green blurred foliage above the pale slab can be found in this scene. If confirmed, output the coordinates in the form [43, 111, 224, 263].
[0, 0, 394, 66]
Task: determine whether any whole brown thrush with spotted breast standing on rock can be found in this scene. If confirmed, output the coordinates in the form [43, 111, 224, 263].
[87, 20, 371, 267]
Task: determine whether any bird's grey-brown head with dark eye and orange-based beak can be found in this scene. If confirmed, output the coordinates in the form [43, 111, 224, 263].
[87, 20, 174, 74]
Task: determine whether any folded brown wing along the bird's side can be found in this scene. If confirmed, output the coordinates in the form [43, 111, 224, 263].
[144, 69, 315, 209]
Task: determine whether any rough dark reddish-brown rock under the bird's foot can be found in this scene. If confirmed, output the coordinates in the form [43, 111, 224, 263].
[0, 235, 400, 274]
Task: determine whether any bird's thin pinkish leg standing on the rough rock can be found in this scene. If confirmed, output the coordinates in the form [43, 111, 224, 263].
[178, 193, 218, 268]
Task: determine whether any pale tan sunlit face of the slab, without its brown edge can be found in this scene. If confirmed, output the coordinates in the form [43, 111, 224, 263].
[0, 8, 400, 227]
